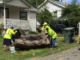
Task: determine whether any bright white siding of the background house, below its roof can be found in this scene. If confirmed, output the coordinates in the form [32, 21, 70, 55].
[39, 2, 63, 18]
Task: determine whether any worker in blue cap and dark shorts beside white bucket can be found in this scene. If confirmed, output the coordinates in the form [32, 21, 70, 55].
[3, 26, 17, 51]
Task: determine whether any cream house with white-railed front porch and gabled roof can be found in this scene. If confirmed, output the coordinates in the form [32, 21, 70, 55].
[0, 0, 37, 32]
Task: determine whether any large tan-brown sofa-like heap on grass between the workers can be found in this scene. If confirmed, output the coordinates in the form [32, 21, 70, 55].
[14, 28, 50, 49]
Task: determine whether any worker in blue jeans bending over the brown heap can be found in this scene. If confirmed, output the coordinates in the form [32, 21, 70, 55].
[46, 28, 57, 49]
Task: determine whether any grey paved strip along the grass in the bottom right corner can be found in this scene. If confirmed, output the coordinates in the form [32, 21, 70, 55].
[26, 47, 80, 60]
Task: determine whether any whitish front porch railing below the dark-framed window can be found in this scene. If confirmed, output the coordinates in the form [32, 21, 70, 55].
[5, 19, 29, 30]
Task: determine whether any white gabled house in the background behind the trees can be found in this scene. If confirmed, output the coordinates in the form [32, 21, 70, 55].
[38, 0, 67, 18]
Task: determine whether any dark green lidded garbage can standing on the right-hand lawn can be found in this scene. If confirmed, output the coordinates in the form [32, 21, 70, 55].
[62, 27, 75, 43]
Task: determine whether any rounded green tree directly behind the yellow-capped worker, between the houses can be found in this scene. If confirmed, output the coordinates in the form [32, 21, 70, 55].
[37, 9, 53, 24]
